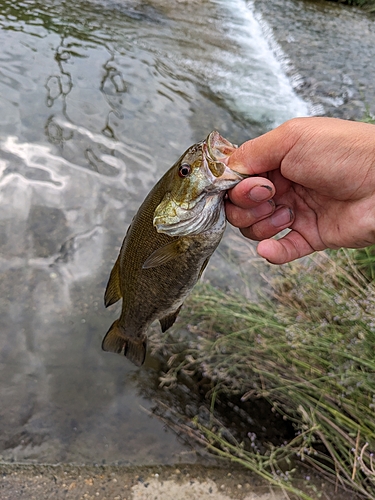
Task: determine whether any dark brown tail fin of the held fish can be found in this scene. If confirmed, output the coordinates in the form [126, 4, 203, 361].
[102, 319, 147, 366]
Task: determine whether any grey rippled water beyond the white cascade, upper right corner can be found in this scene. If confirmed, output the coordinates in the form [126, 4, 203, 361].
[253, 0, 375, 120]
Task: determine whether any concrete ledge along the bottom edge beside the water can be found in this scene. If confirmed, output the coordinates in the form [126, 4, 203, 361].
[0, 464, 354, 500]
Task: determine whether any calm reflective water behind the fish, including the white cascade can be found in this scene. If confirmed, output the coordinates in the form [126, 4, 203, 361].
[0, 0, 308, 464]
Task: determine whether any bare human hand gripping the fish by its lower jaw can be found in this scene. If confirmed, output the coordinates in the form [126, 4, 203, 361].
[226, 117, 375, 264]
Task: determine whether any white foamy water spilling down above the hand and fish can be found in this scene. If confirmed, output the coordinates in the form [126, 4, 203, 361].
[207, 0, 309, 126]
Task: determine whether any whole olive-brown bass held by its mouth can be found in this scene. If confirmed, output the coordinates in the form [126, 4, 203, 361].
[102, 131, 248, 366]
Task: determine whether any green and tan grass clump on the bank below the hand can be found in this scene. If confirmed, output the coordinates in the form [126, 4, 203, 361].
[156, 248, 375, 499]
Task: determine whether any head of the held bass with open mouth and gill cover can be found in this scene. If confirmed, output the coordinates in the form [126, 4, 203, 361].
[153, 131, 247, 236]
